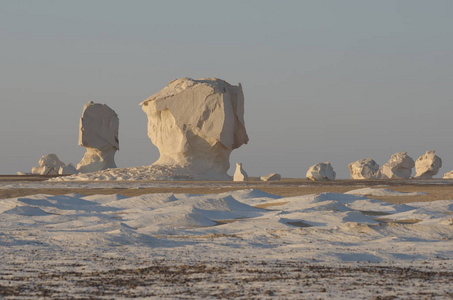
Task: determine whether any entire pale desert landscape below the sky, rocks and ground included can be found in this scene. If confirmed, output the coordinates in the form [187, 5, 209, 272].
[0, 78, 453, 299]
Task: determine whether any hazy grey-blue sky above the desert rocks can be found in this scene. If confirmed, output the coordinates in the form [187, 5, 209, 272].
[0, 0, 453, 178]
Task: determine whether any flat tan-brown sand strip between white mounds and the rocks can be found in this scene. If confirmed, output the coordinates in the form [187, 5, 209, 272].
[0, 175, 453, 203]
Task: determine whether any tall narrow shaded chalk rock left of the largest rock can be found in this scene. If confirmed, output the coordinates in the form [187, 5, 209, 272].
[77, 101, 119, 173]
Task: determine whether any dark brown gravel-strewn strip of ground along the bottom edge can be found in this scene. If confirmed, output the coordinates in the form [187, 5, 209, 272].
[0, 257, 453, 299]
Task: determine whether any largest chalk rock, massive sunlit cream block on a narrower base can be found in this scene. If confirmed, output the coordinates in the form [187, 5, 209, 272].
[140, 78, 248, 180]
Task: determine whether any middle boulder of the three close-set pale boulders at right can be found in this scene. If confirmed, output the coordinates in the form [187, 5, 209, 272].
[381, 152, 415, 179]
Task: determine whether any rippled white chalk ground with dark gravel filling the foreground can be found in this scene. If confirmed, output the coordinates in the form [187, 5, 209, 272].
[0, 189, 453, 299]
